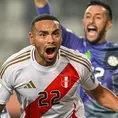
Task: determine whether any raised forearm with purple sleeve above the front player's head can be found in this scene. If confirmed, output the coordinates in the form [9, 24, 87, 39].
[34, 0, 53, 15]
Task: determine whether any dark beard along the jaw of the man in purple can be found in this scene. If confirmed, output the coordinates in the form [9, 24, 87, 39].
[85, 25, 106, 45]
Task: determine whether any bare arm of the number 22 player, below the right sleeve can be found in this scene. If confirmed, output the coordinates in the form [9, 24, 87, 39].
[87, 84, 118, 112]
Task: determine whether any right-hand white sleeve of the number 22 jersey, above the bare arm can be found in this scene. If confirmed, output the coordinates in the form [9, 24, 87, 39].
[75, 50, 99, 90]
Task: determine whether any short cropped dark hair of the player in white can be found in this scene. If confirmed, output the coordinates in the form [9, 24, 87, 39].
[31, 14, 60, 30]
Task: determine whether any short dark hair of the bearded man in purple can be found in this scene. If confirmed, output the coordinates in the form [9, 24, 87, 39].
[86, 0, 113, 20]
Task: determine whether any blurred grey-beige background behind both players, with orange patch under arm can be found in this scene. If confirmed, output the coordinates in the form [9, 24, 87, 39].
[0, 0, 118, 118]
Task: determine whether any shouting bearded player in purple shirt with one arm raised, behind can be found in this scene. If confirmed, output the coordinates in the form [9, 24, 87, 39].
[35, 0, 118, 118]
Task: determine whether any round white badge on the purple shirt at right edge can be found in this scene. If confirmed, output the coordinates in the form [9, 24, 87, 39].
[107, 56, 118, 67]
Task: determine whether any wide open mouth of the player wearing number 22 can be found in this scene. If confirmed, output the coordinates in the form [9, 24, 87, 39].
[45, 46, 56, 59]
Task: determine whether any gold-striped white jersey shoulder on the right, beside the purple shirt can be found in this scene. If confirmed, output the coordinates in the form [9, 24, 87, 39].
[60, 46, 92, 70]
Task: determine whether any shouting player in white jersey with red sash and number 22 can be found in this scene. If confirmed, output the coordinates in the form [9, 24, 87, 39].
[0, 15, 118, 118]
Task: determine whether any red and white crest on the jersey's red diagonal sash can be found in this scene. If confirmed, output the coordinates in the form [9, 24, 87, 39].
[61, 75, 71, 88]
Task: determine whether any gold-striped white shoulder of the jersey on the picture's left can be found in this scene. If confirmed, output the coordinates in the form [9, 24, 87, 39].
[0, 46, 33, 75]
